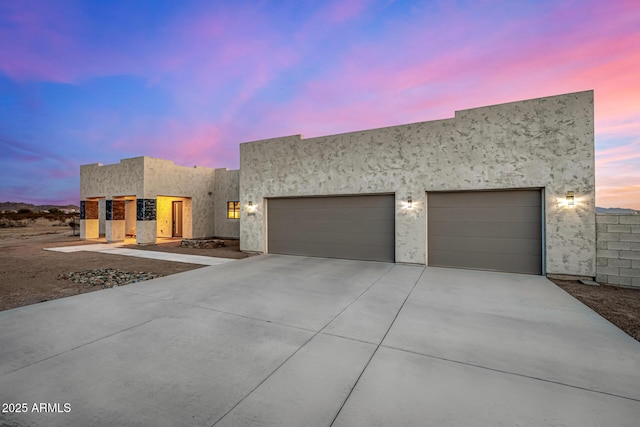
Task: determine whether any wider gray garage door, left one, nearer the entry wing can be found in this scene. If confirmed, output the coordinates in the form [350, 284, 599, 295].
[267, 195, 395, 262]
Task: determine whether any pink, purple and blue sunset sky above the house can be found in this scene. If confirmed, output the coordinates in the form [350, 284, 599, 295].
[0, 0, 640, 209]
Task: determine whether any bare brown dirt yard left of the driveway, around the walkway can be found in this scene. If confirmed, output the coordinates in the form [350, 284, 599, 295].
[0, 220, 248, 311]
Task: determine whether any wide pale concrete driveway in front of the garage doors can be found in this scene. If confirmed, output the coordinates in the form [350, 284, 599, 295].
[0, 255, 640, 427]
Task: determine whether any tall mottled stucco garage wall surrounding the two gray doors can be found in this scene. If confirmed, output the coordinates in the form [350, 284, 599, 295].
[240, 91, 595, 276]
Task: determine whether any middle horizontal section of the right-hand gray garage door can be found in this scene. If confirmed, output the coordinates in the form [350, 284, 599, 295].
[429, 221, 540, 239]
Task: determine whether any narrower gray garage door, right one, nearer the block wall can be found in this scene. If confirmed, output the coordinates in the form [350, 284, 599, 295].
[427, 190, 542, 274]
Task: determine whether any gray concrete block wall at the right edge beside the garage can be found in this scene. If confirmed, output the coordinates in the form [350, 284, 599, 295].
[596, 214, 640, 288]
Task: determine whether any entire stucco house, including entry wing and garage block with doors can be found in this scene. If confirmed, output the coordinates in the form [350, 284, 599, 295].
[80, 91, 596, 277]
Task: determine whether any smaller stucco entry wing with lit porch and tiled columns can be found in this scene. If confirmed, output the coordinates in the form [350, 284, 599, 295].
[80, 157, 240, 244]
